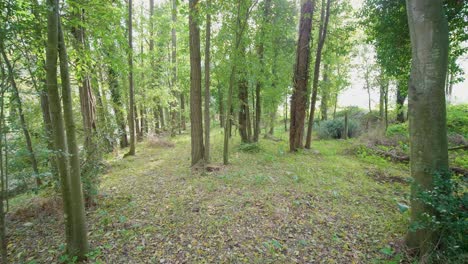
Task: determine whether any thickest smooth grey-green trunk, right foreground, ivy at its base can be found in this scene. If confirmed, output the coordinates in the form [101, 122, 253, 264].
[406, 0, 450, 256]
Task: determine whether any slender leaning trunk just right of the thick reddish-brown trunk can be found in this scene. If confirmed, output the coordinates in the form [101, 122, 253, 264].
[305, 0, 332, 149]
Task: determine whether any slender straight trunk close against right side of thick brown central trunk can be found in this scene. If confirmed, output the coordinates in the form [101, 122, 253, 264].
[204, 0, 211, 163]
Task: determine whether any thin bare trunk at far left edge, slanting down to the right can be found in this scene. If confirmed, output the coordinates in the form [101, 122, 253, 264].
[0, 40, 42, 188]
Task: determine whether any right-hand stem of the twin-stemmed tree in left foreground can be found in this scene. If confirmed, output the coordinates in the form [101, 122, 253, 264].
[58, 17, 89, 260]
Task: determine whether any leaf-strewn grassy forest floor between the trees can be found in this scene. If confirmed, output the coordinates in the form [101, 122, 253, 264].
[7, 130, 409, 263]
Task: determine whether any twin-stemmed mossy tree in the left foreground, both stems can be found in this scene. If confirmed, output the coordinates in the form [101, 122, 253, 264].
[46, 0, 88, 259]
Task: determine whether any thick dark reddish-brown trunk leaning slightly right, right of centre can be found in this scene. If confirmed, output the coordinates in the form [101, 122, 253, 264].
[289, 0, 314, 152]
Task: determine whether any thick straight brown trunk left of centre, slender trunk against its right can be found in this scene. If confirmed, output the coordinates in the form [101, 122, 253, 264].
[189, 0, 204, 166]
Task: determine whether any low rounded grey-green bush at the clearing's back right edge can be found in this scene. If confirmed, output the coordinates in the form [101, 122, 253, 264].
[317, 118, 359, 139]
